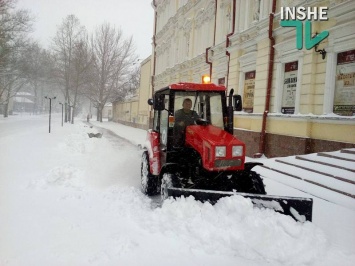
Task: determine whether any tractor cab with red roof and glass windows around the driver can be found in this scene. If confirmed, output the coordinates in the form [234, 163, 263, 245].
[149, 83, 227, 150]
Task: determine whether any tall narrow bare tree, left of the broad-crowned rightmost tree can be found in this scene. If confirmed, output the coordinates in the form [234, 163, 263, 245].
[53, 15, 86, 122]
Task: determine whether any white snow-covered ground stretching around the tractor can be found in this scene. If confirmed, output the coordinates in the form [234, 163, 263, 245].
[0, 115, 355, 266]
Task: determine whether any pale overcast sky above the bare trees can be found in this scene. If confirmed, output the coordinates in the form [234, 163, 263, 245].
[17, 0, 154, 59]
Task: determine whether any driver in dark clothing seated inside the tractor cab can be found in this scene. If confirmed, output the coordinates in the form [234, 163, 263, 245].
[174, 98, 200, 146]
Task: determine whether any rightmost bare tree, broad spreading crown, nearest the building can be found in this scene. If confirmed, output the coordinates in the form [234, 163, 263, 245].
[88, 23, 136, 122]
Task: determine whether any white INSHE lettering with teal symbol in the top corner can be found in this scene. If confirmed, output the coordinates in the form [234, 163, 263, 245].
[280, 7, 329, 50]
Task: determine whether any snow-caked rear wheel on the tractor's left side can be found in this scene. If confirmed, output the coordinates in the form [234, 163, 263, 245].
[141, 151, 158, 196]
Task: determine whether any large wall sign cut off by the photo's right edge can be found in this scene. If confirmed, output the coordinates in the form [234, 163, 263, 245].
[333, 50, 355, 116]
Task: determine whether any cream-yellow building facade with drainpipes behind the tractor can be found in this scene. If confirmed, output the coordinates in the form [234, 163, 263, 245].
[153, 0, 355, 157]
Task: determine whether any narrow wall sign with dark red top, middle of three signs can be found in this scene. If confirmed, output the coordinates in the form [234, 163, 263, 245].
[281, 61, 298, 114]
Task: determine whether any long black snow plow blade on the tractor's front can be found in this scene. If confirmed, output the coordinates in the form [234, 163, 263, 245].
[168, 188, 313, 222]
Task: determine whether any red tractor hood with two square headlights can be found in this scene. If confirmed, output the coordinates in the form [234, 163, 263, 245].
[185, 125, 245, 171]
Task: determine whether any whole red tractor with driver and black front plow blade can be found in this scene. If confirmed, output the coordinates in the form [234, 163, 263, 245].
[141, 83, 313, 221]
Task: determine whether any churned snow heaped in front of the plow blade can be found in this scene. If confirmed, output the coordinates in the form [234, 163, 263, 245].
[146, 196, 328, 265]
